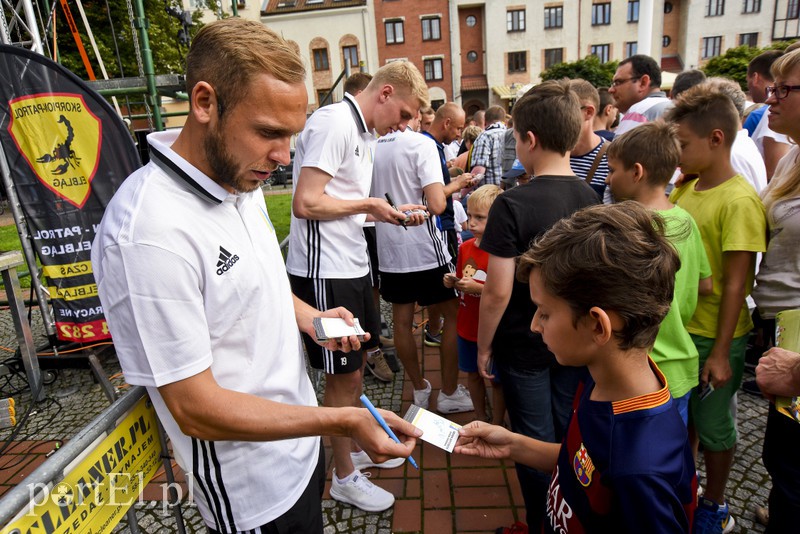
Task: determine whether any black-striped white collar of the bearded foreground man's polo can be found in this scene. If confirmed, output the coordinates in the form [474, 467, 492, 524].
[147, 130, 230, 204]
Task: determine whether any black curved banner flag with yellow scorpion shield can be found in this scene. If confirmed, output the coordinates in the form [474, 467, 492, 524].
[0, 45, 141, 343]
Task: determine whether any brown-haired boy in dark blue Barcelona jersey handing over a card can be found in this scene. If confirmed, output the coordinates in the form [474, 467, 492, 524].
[455, 201, 697, 533]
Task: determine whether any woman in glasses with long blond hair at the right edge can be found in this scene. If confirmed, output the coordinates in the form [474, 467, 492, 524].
[753, 50, 800, 534]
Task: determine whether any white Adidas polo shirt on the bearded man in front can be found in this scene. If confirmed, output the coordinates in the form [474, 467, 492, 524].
[92, 131, 319, 532]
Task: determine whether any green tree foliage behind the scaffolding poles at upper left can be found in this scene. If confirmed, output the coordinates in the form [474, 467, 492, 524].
[46, 0, 216, 80]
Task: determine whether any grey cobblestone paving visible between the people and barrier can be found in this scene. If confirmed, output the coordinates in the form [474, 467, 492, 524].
[0, 304, 770, 534]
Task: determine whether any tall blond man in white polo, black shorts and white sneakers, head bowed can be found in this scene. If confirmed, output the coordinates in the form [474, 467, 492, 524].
[286, 61, 428, 512]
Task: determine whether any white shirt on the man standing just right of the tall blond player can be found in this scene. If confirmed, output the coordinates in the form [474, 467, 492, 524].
[372, 128, 450, 273]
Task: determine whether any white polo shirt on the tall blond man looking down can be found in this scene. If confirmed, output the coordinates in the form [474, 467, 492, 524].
[286, 94, 375, 279]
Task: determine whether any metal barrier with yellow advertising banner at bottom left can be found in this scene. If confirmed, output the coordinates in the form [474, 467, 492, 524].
[0, 386, 186, 534]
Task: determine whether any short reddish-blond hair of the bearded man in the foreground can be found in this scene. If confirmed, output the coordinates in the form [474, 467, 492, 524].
[186, 17, 306, 114]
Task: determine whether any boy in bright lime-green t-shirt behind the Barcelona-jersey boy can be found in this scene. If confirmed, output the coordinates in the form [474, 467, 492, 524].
[608, 121, 712, 425]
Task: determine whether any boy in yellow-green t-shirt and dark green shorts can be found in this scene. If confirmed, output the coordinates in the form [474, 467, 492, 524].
[666, 85, 766, 534]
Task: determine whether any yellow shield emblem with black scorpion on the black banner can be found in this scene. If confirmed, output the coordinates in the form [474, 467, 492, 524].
[8, 93, 102, 209]
